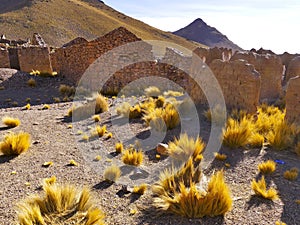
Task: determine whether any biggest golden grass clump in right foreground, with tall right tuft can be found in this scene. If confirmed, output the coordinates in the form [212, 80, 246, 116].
[155, 171, 232, 218]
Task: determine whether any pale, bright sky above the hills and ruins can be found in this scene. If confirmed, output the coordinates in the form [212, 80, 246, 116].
[104, 0, 300, 53]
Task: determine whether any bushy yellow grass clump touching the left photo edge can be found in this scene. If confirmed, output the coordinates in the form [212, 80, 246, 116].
[0, 131, 31, 155]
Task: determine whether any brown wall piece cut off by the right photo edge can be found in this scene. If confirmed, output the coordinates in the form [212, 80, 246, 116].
[286, 76, 300, 125]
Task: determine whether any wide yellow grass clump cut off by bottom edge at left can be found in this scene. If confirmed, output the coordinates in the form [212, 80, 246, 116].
[17, 183, 104, 225]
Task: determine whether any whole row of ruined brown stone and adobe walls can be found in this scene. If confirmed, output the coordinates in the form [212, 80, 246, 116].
[0, 27, 300, 122]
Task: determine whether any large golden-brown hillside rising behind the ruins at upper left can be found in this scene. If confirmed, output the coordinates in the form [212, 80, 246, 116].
[0, 0, 203, 49]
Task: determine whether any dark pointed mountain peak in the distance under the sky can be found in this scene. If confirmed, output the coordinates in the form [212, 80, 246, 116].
[173, 19, 241, 50]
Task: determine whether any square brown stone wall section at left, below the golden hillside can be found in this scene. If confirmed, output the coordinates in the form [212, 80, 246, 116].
[18, 46, 53, 74]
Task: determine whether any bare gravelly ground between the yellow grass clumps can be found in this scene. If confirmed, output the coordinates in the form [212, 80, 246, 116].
[0, 70, 300, 225]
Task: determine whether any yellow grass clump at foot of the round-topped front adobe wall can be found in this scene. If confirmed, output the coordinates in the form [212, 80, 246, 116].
[223, 118, 253, 148]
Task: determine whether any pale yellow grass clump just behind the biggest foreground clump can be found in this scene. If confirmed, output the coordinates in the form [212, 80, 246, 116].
[167, 134, 205, 162]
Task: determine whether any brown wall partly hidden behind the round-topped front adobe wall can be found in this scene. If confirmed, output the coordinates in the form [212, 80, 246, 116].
[231, 52, 283, 102]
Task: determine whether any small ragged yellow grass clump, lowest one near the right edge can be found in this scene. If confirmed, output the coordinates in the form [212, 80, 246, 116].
[251, 176, 278, 200]
